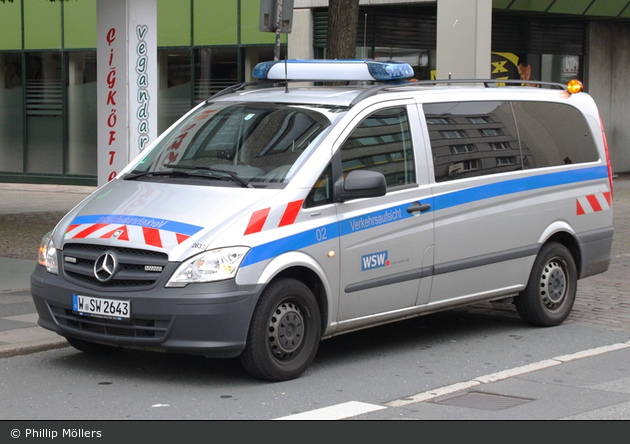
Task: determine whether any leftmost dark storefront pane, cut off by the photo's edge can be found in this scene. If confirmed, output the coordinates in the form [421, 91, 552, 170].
[0, 52, 24, 173]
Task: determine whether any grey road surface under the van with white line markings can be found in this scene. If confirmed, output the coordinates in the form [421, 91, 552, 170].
[0, 178, 630, 421]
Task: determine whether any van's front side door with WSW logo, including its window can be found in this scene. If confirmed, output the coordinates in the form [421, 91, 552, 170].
[336, 100, 433, 323]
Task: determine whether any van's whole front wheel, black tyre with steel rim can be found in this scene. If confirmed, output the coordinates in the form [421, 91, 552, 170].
[240, 279, 321, 381]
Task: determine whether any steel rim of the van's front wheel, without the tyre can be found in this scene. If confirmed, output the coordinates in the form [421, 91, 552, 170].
[267, 301, 304, 360]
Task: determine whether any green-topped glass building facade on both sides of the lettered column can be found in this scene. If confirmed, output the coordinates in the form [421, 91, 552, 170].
[0, 0, 286, 185]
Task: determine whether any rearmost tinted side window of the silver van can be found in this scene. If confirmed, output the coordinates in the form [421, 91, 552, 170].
[512, 102, 599, 168]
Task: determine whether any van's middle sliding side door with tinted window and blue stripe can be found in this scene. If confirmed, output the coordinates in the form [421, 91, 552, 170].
[423, 101, 541, 305]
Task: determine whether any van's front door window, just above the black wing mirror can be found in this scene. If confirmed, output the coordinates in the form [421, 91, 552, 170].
[341, 107, 416, 189]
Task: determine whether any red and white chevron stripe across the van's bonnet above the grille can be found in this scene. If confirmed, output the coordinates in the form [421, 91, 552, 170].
[66, 224, 190, 250]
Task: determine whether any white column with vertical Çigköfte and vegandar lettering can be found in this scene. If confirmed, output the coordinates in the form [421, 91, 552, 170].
[96, 0, 158, 186]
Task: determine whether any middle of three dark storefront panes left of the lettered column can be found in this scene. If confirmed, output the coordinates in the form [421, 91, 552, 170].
[25, 51, 63, 174]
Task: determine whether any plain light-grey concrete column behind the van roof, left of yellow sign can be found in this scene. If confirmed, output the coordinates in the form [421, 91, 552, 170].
[436, 0, 492, 79]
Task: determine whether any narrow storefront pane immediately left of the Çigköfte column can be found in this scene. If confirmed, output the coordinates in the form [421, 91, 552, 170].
[65, 51, 97, 175]
